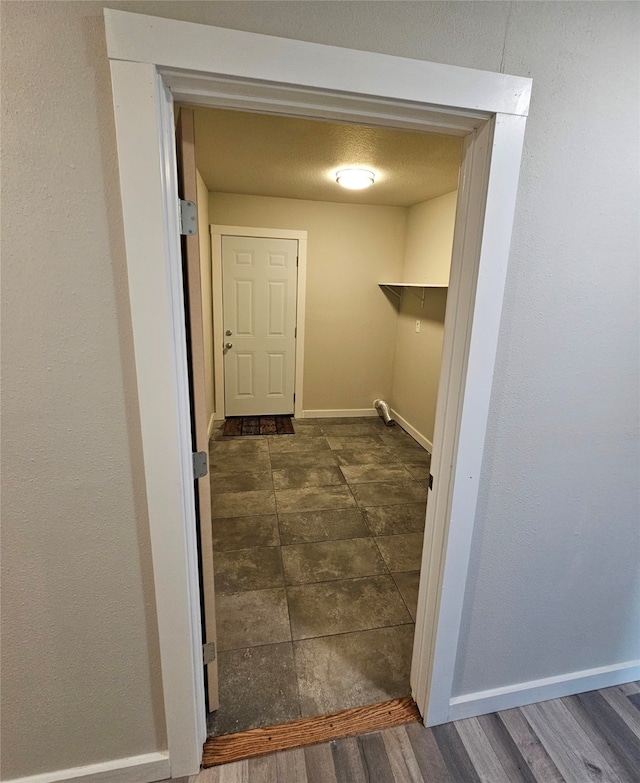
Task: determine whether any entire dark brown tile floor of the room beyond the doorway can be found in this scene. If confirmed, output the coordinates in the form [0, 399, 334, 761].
[209, 418, 431, 734]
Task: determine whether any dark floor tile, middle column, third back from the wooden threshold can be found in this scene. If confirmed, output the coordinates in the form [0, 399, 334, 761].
[282, 538, 388, 585]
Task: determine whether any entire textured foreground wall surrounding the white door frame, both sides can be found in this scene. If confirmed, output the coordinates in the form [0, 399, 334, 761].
[2, 1, 640, 777]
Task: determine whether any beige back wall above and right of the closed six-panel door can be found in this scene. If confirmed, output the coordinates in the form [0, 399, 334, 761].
[209, 193, 406, 410]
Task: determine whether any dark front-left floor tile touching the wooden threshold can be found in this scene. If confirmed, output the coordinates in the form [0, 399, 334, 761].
[208, 642, 300, 735]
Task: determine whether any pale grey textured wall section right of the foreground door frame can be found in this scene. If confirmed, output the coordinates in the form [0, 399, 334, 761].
[456, 3, 640, 693]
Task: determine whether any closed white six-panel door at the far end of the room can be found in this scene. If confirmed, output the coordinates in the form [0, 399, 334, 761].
[222, 236, 298, 416]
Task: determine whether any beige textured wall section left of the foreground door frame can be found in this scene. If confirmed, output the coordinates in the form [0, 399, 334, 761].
[0, 3, 166, 780]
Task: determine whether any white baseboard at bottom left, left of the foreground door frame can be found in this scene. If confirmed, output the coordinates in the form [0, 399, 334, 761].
[4, 753, 171, 783]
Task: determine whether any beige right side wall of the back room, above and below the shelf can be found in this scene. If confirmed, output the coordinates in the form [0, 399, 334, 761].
[391, 191, 457, 443]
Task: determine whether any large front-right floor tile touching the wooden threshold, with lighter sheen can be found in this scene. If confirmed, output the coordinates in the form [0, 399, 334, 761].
[293, 624, 414, 717]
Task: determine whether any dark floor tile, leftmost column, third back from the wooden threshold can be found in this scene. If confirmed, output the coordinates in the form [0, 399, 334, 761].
[213, 541, 284, 595]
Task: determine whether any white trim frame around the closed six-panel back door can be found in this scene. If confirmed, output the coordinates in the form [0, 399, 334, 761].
[210, 224, 307, 420]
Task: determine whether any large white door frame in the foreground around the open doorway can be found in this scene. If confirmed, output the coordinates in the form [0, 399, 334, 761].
[104, 9, 531, 777]
